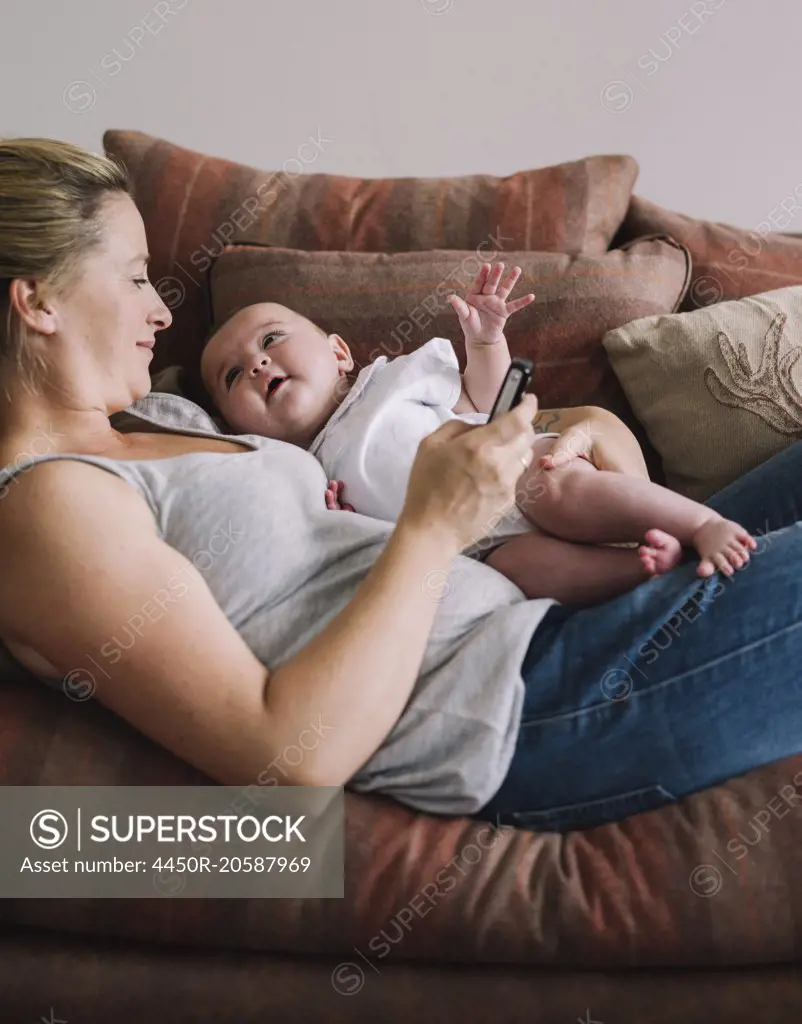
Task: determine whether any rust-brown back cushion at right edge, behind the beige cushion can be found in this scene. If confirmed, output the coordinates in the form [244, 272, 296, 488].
[614, 196, 802, 310]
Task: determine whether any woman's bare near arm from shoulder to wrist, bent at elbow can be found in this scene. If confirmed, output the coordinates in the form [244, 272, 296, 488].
[0, 461, 460, 785]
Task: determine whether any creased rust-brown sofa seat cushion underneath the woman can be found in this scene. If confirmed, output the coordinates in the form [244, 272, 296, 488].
[0, 679, 802, 966]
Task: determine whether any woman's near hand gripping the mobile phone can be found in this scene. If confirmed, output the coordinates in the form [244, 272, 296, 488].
[398, 394, 538, 551]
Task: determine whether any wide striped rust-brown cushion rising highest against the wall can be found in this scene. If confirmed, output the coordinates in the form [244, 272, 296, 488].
[103, 131, 638, 370]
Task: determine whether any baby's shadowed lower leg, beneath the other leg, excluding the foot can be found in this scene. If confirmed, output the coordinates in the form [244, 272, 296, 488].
[486, 534, 663, 605]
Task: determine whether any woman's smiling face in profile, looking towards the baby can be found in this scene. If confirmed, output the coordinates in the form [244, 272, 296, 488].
[45, 194, 172, 414]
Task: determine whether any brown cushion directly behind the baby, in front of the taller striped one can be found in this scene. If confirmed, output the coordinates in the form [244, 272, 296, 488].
[209, 238, 689, 479]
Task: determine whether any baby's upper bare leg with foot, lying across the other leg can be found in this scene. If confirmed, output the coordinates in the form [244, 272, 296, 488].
[515, 437, 756, 575]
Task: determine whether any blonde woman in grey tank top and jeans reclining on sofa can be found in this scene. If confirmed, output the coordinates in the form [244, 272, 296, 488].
[0, 140, 802, 830]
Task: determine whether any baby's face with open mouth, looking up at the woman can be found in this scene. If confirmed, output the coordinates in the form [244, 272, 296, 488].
[201, 302, 353, 447]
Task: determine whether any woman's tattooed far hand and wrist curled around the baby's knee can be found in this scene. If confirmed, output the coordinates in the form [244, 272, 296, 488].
[538, 406, 649, 480]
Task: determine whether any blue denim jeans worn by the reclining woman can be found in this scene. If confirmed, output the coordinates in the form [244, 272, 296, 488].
[476, 441, 802, 831]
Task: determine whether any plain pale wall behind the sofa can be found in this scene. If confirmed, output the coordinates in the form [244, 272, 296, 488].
[0, 0, 802, 231]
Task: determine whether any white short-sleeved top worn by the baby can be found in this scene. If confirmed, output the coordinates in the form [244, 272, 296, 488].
[309, 338, 559, 557]
